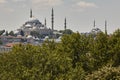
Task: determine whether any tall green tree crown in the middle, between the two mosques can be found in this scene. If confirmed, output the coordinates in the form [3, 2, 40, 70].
[62, 33, 88, 67]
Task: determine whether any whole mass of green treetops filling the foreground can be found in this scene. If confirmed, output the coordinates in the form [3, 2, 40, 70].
[0, 29, 120, 80]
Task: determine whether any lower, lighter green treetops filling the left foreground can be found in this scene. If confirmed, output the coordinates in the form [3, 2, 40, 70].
[0, 41, 84, 80]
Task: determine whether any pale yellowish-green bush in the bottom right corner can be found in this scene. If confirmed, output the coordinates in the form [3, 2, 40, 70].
[86, 66, 120, 80]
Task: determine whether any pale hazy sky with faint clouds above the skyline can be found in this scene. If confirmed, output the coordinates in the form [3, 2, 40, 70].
[0, 0, 120, 33]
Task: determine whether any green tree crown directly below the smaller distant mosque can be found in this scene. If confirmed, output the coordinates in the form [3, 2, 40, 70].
[90, 33, 111, 69]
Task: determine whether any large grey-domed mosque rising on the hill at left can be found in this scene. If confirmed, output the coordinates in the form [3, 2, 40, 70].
[18, 9, 53, 36]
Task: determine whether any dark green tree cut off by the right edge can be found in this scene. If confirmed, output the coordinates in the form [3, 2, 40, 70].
[109, 29, 120, 66]
